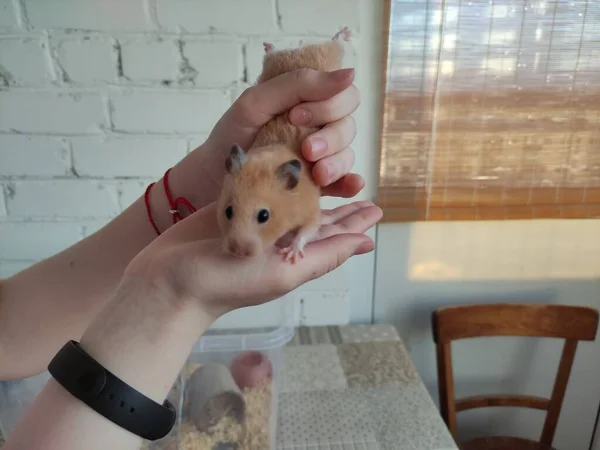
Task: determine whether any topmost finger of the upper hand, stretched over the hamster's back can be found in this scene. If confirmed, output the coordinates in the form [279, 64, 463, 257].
[231, 69, 354, 132]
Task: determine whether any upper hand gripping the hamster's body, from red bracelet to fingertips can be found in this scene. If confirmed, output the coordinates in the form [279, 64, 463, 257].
[162, 69, 365, 223]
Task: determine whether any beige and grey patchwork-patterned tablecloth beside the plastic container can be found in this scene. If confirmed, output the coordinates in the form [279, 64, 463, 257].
[277, 325, 457, 450]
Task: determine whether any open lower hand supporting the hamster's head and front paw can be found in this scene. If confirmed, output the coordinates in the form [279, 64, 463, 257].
[126, 202, 382, 320]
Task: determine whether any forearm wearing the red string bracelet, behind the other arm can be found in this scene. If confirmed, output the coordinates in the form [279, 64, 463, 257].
[0, 142, 219, 379]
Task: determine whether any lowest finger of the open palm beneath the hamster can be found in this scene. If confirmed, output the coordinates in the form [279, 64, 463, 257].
[286, 234, 375, 286]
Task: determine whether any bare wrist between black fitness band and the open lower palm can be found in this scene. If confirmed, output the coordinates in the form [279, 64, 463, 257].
[80, 277, 212, 403]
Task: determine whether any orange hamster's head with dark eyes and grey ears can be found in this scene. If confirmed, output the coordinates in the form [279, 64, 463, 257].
[217, 144, 302, 257]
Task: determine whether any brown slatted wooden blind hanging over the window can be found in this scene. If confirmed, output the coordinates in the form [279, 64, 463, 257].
[377, 0, 600, 222]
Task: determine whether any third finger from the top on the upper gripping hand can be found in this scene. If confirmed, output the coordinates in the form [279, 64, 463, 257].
[302, 116, 356, 161]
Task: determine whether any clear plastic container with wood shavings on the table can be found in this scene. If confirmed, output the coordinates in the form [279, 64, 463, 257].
[0, 296, 294, 450]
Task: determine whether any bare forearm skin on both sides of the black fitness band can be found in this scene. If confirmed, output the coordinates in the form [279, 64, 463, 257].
[3, 274, 212, 450]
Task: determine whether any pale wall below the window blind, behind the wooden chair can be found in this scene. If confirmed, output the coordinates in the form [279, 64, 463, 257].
[375, 220, 600, 450]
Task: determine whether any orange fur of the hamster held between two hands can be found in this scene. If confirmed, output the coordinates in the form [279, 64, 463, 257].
[217, 28, 344, 262]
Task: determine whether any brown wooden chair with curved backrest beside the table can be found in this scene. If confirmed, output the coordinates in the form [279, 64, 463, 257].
[432, 304, 598, 450]
